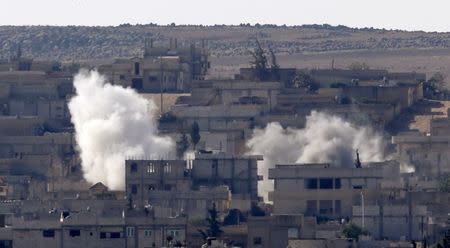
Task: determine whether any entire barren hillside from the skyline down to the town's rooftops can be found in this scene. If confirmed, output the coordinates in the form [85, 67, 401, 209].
[4, 24, 450, 83]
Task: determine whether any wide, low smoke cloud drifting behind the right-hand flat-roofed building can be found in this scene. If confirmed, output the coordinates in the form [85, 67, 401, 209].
[247, 111, 385, 199]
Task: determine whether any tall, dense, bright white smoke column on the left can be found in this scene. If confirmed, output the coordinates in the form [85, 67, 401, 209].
[69, 70, 174, 190]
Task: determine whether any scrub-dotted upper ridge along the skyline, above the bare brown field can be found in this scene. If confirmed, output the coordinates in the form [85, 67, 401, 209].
[0, 23, 450, 61]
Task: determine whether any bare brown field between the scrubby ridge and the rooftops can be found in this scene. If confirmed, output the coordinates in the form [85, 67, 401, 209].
[210, 49, 450, 83]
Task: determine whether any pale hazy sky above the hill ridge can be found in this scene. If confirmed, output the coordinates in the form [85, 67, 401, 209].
[0, 0, 450, 31]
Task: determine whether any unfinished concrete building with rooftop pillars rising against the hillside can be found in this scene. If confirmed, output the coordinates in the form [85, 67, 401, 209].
[99, 39, 210, 92]
